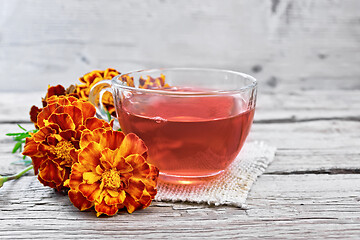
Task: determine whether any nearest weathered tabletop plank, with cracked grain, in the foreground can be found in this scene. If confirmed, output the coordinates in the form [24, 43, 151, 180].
[0, 175, 360, 239]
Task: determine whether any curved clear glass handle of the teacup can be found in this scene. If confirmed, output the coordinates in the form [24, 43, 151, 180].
[89, 80, 114, 120]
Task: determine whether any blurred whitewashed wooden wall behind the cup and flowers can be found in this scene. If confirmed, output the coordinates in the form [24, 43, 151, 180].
[0, 0, 360, 91]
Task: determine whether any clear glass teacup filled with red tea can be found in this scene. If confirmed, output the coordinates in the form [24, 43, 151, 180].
[90, 68, 257, 183]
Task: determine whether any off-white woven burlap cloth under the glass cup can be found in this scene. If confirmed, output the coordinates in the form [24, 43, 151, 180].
[155, 142, 276, 208]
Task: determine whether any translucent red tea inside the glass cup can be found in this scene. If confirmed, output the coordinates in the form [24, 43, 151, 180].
[117, 89, 254, 181]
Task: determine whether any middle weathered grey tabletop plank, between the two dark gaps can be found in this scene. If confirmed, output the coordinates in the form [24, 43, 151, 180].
[0, 121, 360, 174]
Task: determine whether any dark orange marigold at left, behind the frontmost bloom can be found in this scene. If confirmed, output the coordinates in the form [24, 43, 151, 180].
[23, 95, 111, 190]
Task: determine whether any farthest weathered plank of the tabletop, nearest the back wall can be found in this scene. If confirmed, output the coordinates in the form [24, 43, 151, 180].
[0, 90, 360, 123]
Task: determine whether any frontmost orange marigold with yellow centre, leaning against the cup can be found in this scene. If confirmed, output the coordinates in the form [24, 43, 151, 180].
[69, 129, 159, 216]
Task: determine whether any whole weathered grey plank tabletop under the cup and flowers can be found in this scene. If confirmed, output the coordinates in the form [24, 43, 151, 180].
[0, 78, 360, 239]
